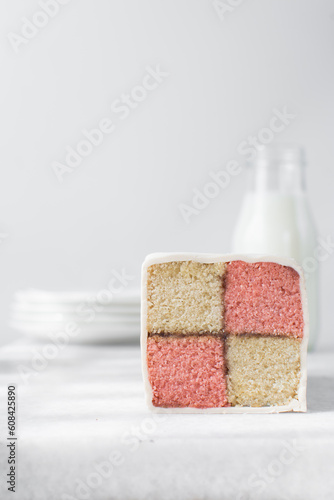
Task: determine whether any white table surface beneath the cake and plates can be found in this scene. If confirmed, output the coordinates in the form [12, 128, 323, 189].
[0, 341, 334, 500]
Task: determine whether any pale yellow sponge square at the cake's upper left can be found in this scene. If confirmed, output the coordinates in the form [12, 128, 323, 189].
[147, 261, 226, 334]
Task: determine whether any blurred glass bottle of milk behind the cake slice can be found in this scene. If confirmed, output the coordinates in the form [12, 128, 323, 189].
[233, 146, 318, 349]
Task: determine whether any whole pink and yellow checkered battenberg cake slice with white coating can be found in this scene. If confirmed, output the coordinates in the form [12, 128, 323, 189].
[141, 253, 308, 413]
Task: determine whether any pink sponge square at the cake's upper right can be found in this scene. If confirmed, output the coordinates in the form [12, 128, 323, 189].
[225, 261, 304, 338]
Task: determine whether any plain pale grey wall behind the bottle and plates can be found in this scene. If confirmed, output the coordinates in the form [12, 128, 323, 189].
[0, 0, 334, 348]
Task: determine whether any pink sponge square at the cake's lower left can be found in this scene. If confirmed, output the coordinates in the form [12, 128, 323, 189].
[147, 335, 229, 408]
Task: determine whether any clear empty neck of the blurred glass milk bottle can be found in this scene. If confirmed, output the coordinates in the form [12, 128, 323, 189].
[250, 147, 306, 195]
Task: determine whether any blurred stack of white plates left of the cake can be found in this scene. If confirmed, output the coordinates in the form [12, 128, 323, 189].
[10, 289, 140, 343]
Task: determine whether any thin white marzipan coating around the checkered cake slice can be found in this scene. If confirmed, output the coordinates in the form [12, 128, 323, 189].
[141, 252, 309, 413]
